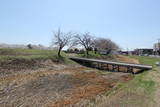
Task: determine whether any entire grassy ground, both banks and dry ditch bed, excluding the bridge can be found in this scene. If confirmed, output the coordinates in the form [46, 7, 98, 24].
[0, 49, 159, 107]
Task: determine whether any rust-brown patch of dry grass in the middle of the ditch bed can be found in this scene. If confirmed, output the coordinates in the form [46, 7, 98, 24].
[53, 72, 114, 107]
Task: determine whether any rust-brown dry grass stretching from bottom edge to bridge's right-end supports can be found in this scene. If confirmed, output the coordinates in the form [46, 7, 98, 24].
[50, 72, 131, 107]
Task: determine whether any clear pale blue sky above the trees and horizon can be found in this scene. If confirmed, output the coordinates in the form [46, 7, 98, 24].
[0, 0, 160, 50]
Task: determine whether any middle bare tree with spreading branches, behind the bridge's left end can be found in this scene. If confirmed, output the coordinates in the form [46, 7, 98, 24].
[75, 33, 93, 56]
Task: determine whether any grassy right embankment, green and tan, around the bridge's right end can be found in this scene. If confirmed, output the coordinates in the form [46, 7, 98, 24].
[89, 56, 160, 107]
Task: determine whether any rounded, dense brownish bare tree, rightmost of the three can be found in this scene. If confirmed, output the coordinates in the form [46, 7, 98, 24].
[94, 38, 120, 54]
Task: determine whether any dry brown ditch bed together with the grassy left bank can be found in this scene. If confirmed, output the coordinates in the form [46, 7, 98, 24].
[0, 49, 136, 107]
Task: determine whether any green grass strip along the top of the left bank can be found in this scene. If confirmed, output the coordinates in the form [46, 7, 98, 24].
[0, 49, 73, 64]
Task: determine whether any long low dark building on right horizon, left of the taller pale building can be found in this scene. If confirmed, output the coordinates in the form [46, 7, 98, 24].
[134, 49, 153, 55]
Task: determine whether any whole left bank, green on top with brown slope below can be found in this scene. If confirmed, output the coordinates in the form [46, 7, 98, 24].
[0, 48, 74, 76]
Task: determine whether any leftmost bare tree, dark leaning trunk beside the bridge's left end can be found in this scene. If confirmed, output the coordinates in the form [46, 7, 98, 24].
[52, 29, 74, 57]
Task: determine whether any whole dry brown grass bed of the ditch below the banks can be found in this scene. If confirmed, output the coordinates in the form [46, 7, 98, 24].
[0, 54, 136, 107]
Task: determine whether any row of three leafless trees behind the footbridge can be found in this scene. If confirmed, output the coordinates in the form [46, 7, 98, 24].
[52, 29, 120, 57]
